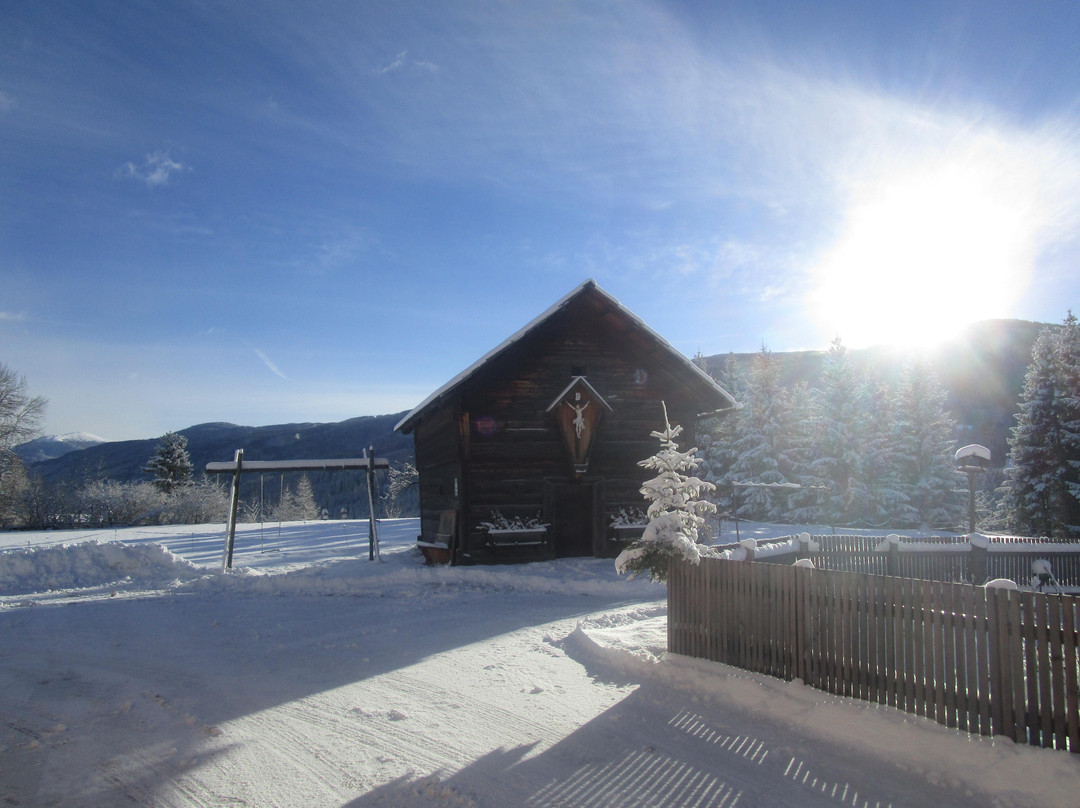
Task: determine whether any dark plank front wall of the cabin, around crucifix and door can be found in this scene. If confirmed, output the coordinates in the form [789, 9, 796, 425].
[460, 311, 697, 543]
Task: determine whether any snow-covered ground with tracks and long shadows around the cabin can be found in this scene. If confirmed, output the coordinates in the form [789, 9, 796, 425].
[0, 520, 1080, 808]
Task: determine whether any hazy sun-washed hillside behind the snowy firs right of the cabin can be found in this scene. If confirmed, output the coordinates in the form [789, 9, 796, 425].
[704, 320, 1057, 466]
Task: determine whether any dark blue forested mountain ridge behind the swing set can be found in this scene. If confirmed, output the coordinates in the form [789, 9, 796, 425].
[29, 413, 413, 516]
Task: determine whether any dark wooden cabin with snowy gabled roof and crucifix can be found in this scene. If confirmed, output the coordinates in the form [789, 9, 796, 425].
[395, 281, 734, 563]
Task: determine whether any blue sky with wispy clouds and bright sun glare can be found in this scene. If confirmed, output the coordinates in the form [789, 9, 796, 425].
[0, 0, 1080, 440]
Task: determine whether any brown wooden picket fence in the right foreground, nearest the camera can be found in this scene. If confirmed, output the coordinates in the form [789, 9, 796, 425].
[667, 558, 1080, 752]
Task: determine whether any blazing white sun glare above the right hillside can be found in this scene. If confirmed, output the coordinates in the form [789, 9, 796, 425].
[813, 166, 1031, 348]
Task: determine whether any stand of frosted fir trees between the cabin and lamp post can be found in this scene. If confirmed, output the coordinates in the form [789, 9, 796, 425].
[703, 340, 972, 527]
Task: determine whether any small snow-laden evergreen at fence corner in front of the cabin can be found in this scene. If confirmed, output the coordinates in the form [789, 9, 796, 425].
[615, 402, 716, 581]
